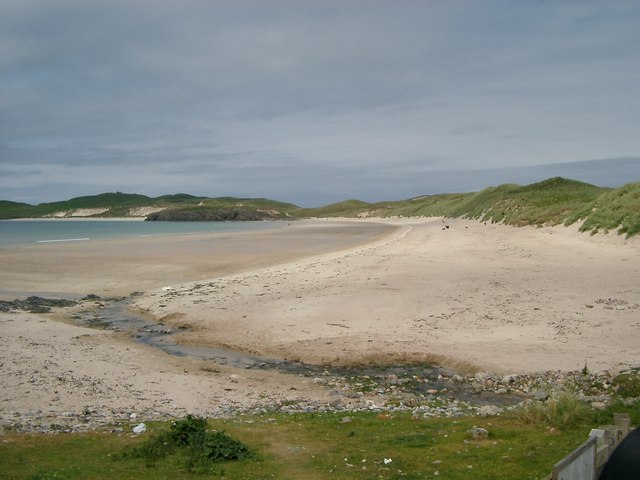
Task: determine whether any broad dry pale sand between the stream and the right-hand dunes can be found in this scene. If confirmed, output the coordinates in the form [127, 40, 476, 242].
[134, 219, 640, 373]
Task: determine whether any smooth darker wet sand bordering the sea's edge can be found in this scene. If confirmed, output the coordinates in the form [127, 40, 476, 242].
[0, 220, 394, 300]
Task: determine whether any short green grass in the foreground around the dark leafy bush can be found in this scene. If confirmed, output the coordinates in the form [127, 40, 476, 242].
[0, 405, 640, 480]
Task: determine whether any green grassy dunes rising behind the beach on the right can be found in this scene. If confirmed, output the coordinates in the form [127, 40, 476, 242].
[304, 177, 640, 237]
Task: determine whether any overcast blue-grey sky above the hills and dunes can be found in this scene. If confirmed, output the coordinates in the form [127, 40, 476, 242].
[0, 0, 640, 206]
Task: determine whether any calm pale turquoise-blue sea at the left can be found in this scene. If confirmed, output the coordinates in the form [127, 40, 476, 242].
[0, 219, 279, 246]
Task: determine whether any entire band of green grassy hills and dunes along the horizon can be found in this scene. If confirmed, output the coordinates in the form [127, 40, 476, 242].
[0, 177, 640, 237]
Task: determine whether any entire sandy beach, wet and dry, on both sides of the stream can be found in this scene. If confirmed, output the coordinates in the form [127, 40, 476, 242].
[0, 219, 640, 413]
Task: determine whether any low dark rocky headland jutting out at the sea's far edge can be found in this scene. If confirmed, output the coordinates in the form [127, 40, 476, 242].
[145, 208, 280, 222]
